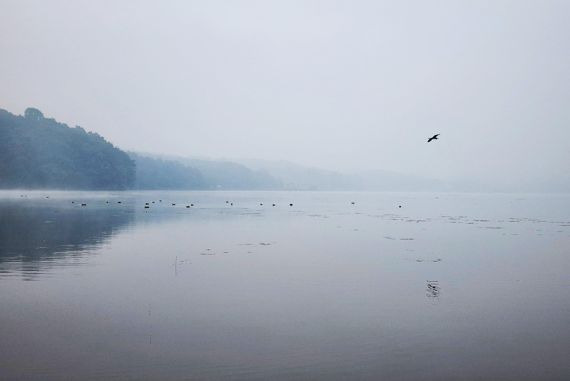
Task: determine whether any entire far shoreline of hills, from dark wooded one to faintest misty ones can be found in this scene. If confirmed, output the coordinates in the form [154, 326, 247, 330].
[4, 108, 568, 192]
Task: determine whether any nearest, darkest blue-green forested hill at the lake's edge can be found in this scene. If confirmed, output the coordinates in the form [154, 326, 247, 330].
[0, 108, 135, 190]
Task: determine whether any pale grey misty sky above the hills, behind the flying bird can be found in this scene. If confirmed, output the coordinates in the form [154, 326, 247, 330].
[0, 0, 570, 189]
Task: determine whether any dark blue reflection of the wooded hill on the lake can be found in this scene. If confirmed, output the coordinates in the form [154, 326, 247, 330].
[0, 201, 133, 280]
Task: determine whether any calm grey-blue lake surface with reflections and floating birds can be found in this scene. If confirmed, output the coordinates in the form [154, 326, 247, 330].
[0, 192, 570, 380]
